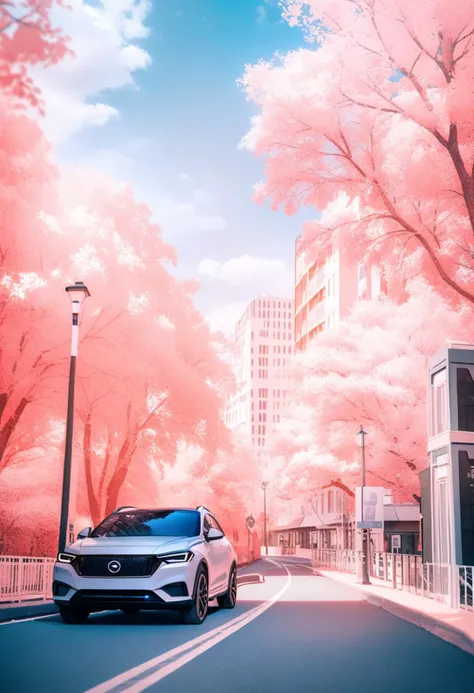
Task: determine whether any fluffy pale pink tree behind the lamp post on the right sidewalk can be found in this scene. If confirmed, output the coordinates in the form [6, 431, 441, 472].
[275, 282, 472, 500]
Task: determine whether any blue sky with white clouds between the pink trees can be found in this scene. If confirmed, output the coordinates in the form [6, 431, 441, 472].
[35, 0, 309, 330]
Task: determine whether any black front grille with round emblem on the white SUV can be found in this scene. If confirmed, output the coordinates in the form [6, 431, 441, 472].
[72, 556, 161, 578]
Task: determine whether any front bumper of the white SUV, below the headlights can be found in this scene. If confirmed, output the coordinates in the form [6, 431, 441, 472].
[53, 561, 199, 611]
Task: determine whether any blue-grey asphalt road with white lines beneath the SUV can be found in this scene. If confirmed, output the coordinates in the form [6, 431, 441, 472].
[0, 558, 474, 693]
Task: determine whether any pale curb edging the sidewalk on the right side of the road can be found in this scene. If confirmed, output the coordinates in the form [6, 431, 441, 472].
[314, 568, 474, 656]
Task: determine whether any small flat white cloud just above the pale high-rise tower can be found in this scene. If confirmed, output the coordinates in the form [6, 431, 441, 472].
[198, 255, 293, 295]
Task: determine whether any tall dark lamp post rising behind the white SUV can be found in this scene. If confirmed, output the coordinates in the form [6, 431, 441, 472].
[59, 282, 90, 551]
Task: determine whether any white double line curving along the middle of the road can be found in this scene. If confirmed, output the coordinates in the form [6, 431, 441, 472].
[86, 559, 291, 693]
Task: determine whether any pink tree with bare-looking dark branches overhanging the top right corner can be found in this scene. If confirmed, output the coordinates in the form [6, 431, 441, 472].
[242, 0, 474, 303]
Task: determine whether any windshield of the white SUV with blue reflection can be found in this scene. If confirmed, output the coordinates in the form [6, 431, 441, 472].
[90, 510, 201, 537]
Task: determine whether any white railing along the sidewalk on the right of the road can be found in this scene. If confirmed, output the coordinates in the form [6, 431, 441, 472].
[312, 549, 474, 611]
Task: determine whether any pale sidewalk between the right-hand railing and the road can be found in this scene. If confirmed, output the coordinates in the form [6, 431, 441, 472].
[314, 568, 474, 655]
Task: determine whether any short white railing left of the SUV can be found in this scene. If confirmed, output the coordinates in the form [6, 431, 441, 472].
[0, 556, 55, 603]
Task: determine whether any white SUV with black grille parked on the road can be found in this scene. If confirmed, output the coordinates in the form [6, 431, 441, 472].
[53, 507, 237, 624]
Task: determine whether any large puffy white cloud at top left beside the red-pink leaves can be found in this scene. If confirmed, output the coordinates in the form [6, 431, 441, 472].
[32, 0, 151, 143]
